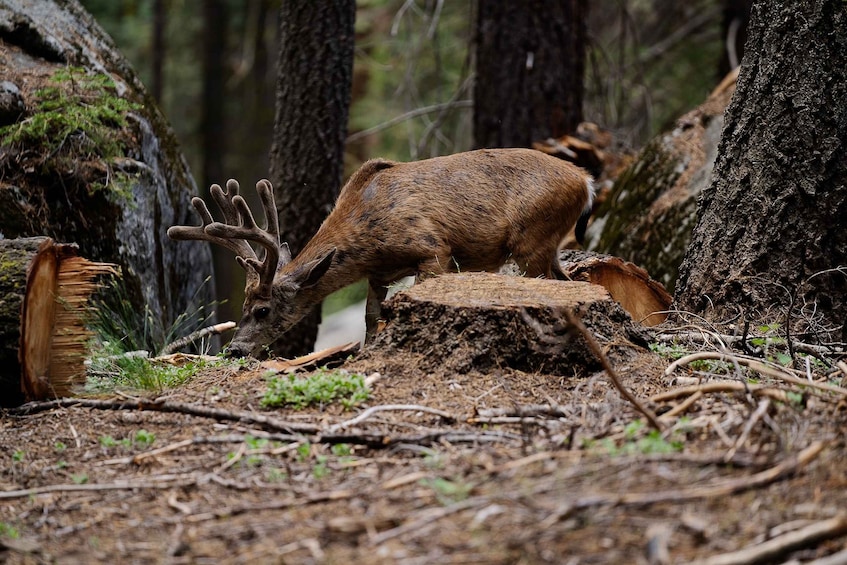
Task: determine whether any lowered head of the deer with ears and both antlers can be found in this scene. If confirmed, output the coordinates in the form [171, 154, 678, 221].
[168, 180, 334, 357]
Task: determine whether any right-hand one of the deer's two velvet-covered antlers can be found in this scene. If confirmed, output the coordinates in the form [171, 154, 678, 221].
[205, 180, 284, 285]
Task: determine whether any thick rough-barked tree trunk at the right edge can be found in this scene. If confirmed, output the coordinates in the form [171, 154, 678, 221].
[675, 0, 847, 340]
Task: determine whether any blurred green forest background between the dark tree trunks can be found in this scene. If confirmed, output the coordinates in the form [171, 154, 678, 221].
[82, 0, 750, 328]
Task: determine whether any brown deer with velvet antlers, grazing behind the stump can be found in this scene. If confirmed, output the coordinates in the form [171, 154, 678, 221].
[168, 148, 594, 358]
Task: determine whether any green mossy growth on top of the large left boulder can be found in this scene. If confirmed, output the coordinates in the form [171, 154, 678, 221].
[0, 67, 141, 198]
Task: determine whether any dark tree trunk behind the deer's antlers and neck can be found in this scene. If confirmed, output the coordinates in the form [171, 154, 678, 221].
[270, 0, 356, 356]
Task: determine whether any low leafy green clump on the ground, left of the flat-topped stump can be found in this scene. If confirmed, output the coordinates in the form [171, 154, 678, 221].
[262, 369, 369, 409]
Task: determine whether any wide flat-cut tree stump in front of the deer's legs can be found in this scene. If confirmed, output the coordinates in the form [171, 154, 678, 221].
[372, 273, 646, 375]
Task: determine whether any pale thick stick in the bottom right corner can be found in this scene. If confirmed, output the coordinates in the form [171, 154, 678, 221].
[695, 513, 847, 565]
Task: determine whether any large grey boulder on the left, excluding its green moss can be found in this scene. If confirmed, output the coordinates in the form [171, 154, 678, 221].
[0, 0, 214, 342]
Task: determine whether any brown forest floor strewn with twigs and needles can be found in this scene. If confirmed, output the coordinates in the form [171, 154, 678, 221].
[0, 280, 847, 564]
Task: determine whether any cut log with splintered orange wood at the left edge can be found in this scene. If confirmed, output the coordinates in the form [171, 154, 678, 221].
[0, 237, 115, 406]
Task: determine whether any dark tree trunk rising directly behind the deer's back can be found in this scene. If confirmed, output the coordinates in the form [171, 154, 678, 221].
[473, 0, 588, 148]
